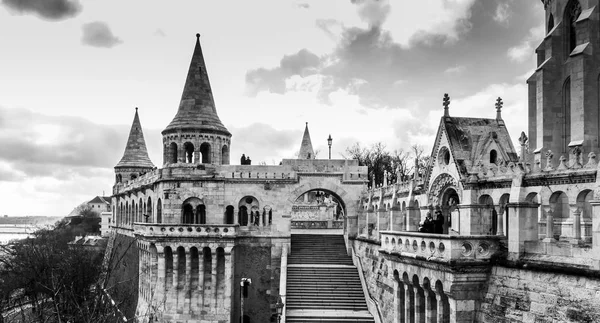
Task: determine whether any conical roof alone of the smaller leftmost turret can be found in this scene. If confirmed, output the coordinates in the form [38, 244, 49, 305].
[115, 108, 154, 168]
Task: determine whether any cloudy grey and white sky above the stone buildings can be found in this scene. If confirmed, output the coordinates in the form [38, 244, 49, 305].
[0, 0, 544, 216]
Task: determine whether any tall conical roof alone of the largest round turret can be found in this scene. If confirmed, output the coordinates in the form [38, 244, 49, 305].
[163, 34, 231, 136]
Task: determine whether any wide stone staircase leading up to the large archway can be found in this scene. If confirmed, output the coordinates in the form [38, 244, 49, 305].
[286, 234, 375, 323]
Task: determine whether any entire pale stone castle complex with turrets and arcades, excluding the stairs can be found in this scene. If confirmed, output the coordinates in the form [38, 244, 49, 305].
[109, 0, 600, 323]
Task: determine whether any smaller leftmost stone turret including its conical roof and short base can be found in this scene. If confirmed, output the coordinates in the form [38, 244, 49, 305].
[115, 108, 154, 183]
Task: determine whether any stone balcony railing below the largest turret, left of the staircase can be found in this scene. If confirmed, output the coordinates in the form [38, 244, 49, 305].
[133, 223, 239, 238]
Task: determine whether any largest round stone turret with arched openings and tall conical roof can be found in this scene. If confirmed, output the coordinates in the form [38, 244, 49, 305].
[162, 34, 231, 166]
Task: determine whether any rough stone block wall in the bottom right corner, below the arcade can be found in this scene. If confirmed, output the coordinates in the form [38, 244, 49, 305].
[477, 266, 600, 323]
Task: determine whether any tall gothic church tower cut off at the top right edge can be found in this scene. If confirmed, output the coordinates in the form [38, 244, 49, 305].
[527, 0, 600, 163]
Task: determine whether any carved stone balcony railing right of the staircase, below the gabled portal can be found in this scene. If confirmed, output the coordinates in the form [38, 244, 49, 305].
[381, 231, 506, 262]
